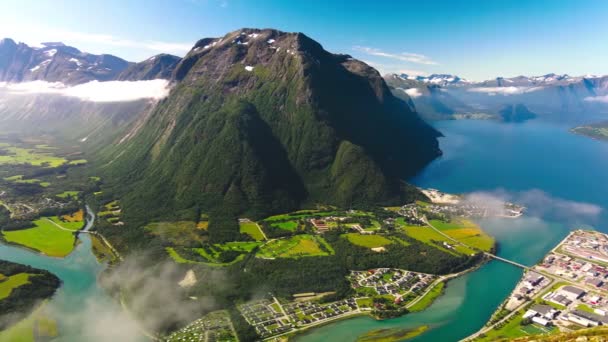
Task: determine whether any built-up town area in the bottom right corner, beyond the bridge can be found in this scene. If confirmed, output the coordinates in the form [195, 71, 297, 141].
[468, 230, 608, 341]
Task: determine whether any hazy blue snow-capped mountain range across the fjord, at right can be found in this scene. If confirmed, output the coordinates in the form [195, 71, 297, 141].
[385, 74, 608, 122]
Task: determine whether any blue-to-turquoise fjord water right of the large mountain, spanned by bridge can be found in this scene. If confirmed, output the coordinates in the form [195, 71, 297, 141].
[297, 121, 608, 342]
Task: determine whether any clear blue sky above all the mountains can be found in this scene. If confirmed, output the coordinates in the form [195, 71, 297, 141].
[0, 0, 608, 80]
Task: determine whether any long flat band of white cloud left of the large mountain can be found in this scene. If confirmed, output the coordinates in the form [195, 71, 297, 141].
[0, 80, 170, 102]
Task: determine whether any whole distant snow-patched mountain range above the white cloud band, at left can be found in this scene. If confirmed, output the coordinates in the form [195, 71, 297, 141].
[0, 38, 180, 85]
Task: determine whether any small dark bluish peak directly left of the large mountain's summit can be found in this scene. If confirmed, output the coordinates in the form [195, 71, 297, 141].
[118, 54, 181, 81]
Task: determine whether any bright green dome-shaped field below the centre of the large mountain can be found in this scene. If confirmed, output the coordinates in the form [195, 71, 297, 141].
[257, 234, 334, 258]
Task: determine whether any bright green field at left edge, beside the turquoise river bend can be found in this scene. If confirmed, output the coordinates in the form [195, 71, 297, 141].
[2, 217, 82, 257]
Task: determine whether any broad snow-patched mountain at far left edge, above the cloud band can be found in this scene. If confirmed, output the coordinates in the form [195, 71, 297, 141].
[0, 38, 131, 84]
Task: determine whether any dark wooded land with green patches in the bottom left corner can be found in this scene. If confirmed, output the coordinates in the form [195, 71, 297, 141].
[0, 260, 61, 341]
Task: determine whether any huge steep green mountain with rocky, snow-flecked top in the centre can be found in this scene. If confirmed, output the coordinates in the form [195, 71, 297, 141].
[102, 29, 441, 220]
